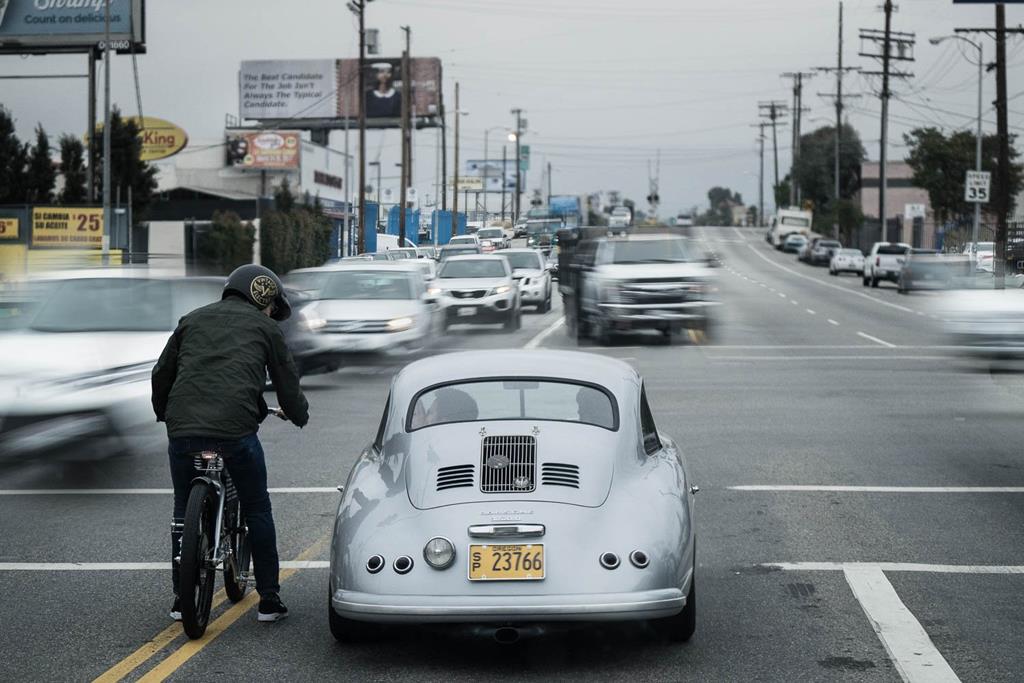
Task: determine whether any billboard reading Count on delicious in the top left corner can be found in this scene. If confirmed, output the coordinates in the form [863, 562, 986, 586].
[0, 0, 145, 52]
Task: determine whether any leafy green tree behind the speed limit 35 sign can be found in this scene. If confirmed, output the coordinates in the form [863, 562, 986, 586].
[903, 127, 1022, 222]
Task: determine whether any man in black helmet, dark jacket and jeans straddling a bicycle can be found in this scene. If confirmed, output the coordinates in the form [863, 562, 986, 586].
[153, 265, 309, 622]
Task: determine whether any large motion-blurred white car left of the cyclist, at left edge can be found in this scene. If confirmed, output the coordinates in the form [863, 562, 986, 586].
[0, 269, 223, 461]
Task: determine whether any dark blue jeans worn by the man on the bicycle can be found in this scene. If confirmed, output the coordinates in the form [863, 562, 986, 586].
[167, 434, 281, 595]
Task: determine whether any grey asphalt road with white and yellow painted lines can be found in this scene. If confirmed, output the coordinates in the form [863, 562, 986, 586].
[0, 228, 1024, 681]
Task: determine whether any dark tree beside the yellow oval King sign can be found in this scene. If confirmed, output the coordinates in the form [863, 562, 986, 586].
[92, 106, 157, 220]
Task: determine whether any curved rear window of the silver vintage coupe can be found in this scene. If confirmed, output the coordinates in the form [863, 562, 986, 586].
[407, 378, 618, 431]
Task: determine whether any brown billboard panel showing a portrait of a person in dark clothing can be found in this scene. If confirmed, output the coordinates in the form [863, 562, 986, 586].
[337, 57, 441, 128]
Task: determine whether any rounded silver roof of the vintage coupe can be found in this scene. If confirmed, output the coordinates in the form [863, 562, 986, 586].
[392, 349, 641, 405]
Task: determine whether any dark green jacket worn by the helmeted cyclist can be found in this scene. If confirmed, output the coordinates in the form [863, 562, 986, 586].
[153, 297, 309, 439]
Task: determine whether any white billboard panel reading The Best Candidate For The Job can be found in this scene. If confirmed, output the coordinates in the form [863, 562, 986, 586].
[238, 59, 338, 120]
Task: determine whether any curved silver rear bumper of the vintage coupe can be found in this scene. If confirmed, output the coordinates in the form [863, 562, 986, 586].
[331, 588, 686, 624]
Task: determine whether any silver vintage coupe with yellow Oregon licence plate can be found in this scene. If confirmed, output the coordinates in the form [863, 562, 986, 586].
[329, 350, 696, 642]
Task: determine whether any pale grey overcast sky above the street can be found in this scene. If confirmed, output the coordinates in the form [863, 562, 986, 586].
[0, 0, 1024, 216]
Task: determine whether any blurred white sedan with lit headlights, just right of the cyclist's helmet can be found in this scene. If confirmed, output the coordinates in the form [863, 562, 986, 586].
[285, 259, 433, 360]
